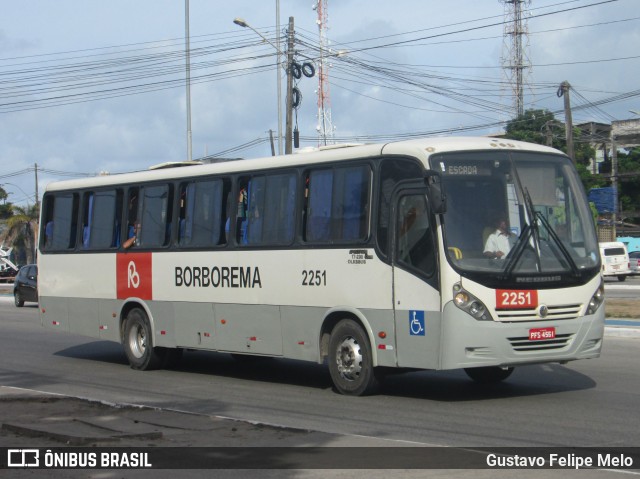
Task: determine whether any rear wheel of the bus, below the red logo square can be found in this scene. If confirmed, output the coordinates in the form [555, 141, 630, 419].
[122, 308, 164, 371]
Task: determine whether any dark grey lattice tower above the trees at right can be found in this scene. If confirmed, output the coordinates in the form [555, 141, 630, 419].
[500, 0, 531, 116]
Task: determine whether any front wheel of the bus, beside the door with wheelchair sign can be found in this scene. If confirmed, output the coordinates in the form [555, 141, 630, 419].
[329, 319, 378, 396]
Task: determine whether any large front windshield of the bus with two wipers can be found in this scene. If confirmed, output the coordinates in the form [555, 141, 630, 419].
[431, 151, 600, 288]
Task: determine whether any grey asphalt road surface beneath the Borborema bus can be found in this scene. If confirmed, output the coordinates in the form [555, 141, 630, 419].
[0, 297, 640, 447]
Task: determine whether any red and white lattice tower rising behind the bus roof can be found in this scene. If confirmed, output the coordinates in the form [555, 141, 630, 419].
[313, 0, 335, 146]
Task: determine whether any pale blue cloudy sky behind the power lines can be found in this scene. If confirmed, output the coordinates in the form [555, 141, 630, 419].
[0, 0, 640, 206]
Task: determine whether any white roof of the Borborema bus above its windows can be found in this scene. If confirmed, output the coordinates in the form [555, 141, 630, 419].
[45, 137, 562, 192]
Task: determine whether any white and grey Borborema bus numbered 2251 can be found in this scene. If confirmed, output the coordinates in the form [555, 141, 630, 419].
[39, 138, 604, 395]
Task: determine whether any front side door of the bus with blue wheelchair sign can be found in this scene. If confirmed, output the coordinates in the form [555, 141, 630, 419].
[391, 188, 441, 369]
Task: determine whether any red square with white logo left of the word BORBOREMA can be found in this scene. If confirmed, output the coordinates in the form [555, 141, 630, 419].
[116, 253, 153, 299]
